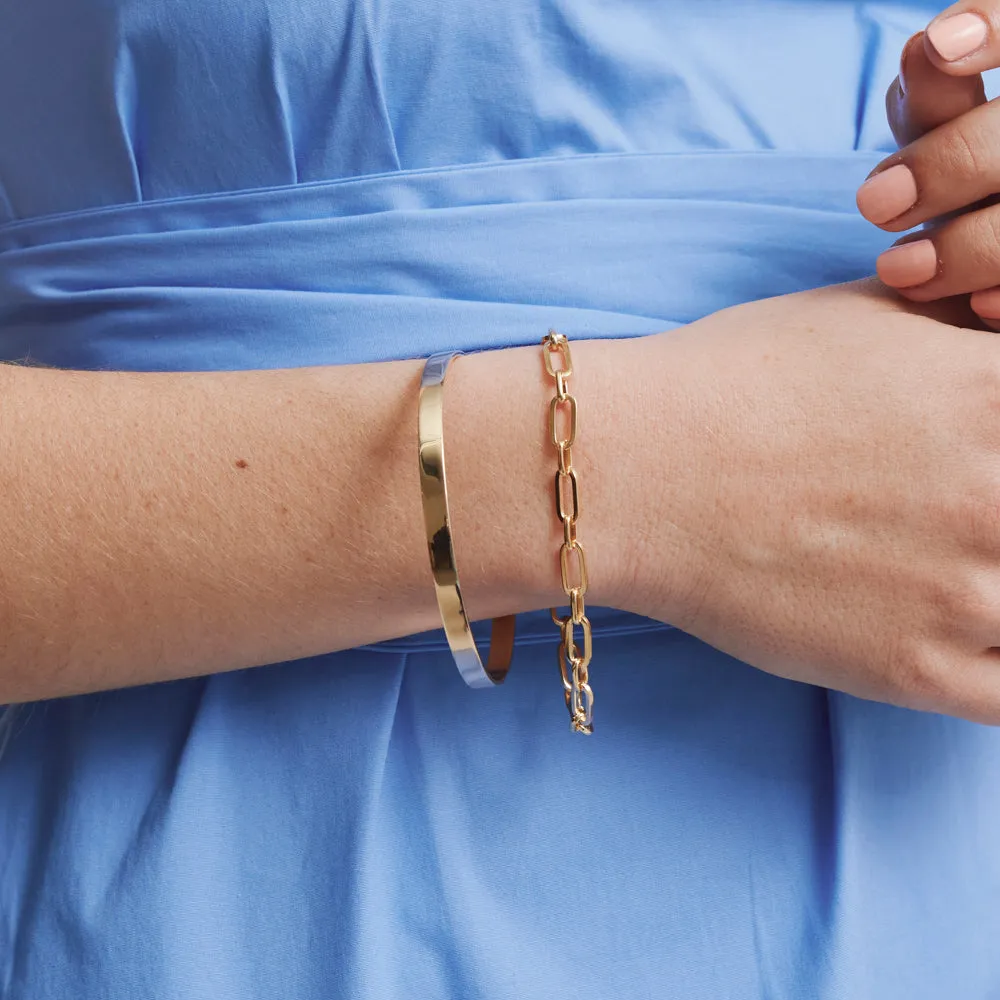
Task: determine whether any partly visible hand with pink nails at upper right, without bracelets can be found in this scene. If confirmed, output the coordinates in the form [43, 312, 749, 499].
[858, 0, 1000, 328]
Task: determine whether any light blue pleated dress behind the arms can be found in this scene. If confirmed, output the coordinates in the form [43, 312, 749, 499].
[0, 0, 1000, 1000]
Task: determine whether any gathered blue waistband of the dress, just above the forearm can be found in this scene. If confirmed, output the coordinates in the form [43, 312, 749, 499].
[0, 152, 886, 370]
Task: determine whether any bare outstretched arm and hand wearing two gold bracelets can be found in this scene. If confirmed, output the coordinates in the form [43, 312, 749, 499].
[9, 7, 1000, 724]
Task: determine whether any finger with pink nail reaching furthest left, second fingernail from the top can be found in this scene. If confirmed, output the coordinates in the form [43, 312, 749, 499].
[857, 101, 1000, 232]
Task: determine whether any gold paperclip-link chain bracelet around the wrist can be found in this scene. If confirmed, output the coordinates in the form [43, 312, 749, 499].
[542, 330, 594, 735]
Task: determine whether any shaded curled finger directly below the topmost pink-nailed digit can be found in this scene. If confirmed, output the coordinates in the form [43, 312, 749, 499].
[886, 32, 986, 146]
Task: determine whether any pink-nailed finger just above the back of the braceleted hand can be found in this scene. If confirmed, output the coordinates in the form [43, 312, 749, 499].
[876, 205, 1000, 302]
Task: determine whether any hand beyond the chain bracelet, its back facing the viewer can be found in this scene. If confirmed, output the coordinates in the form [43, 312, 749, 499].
[616, 281, 1000, 724]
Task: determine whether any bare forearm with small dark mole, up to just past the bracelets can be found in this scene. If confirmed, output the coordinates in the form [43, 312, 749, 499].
[0, 341, 642, 702]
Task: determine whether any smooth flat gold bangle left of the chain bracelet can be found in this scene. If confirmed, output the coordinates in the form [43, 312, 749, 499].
[417, 351, 516, 688]
